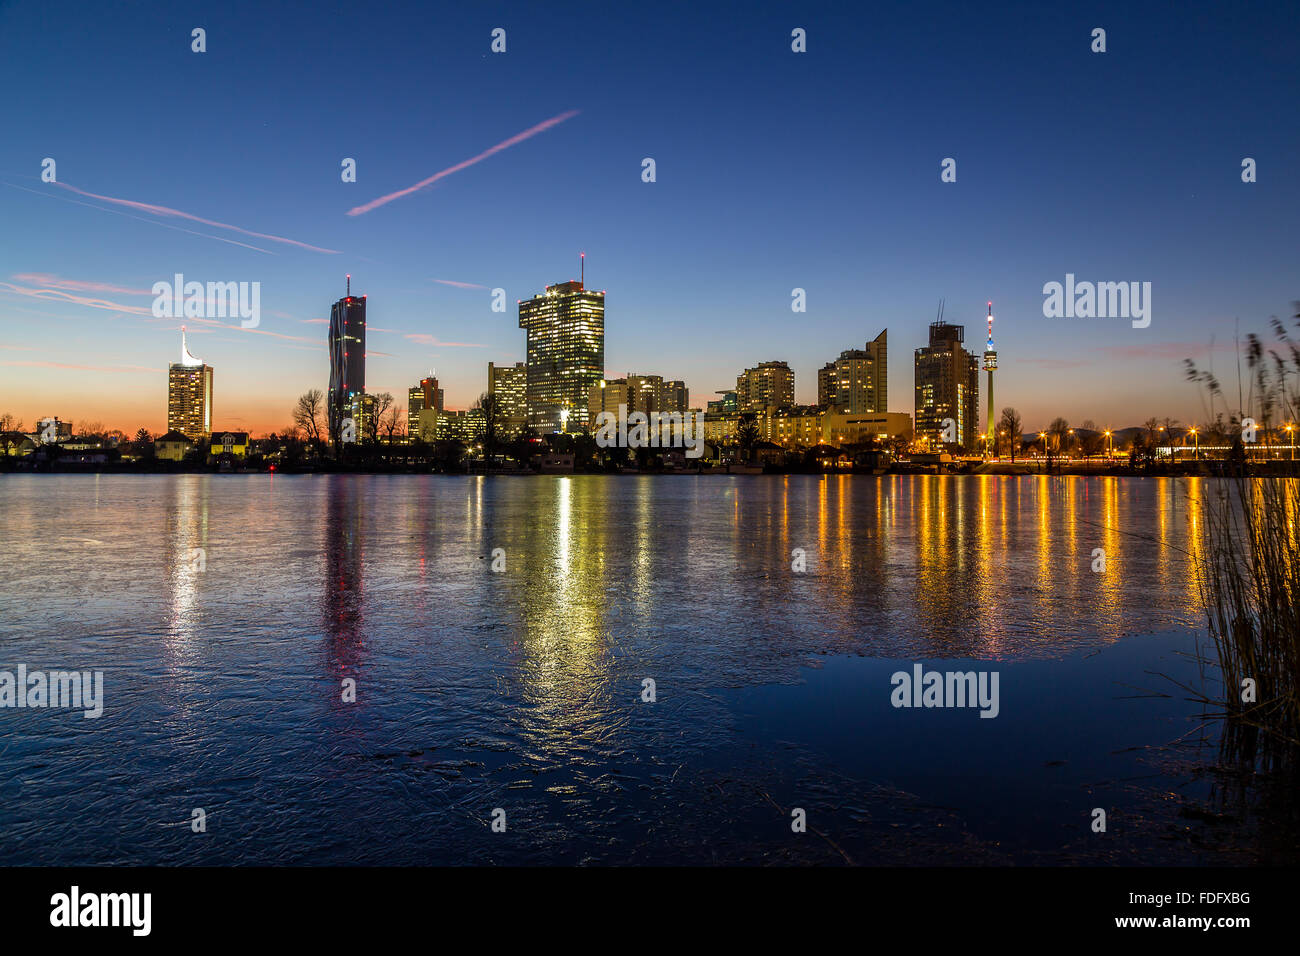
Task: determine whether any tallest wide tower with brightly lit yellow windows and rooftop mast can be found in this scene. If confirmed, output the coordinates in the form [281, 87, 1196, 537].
[519, 273, 605, 433]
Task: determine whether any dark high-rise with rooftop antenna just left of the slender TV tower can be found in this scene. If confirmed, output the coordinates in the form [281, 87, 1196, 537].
[914, 319, 979, 451]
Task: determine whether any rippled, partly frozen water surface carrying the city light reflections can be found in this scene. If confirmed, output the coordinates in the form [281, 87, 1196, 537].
[0, 475, 1216, 862]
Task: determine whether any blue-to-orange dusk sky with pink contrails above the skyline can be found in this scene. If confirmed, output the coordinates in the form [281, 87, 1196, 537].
[0, 1, 1300, 434]
